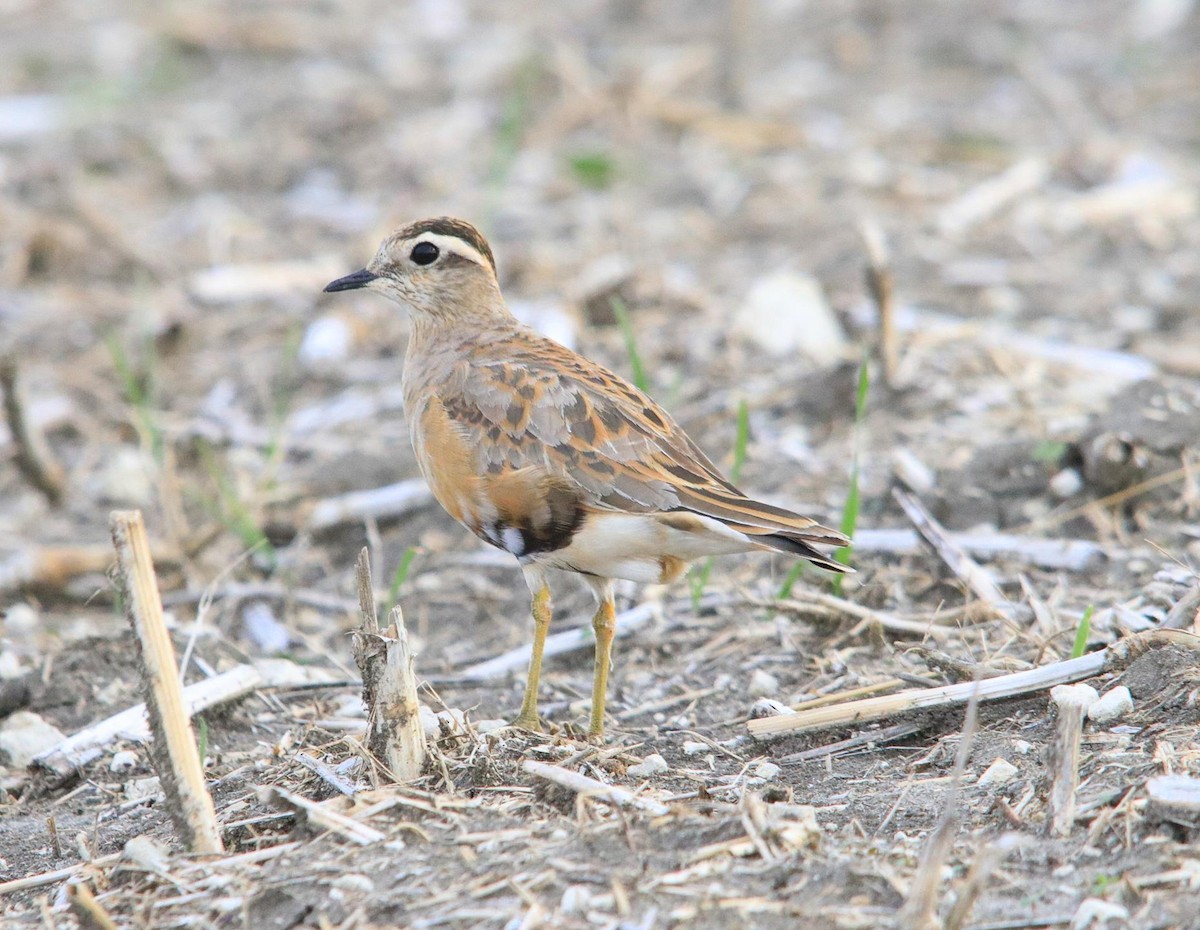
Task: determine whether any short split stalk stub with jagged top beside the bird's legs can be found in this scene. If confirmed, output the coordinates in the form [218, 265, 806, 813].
[354, 548, 426, 782]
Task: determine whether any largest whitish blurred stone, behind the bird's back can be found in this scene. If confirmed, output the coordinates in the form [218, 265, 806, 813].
[733, 271, 847, 365]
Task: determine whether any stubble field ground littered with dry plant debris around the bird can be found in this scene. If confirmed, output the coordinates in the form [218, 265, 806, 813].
[0, 0, 1200, 930]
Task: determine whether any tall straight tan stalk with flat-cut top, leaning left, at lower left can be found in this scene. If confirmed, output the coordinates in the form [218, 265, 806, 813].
[109, 510, 224, 853]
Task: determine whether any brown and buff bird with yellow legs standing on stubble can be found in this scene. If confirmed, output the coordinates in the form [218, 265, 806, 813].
[324, 216, 851, 742]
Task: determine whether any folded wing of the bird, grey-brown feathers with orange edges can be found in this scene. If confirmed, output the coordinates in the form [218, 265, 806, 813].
[439, 331, 846, 548]
